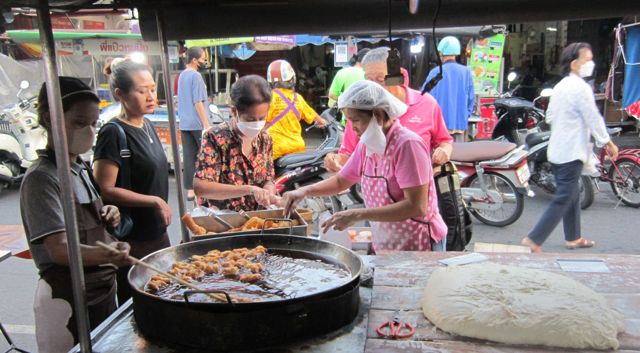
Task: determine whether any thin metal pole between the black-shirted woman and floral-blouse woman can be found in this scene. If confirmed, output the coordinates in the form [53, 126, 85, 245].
[156, 10, 191, 242]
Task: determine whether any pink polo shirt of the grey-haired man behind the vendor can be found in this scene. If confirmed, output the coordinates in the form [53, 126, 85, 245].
[338, 87, 453, 155]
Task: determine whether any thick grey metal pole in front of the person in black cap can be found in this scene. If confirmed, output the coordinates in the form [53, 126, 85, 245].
[34, 0, 91, 353]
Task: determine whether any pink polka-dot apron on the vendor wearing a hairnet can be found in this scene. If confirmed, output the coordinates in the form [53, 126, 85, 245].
[360, 134, 431, 251]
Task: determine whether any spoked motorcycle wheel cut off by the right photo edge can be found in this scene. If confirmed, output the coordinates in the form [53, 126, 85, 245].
[609, 158, 640, 208]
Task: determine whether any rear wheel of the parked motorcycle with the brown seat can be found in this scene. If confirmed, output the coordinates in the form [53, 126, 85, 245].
[469, 172, 524, 227]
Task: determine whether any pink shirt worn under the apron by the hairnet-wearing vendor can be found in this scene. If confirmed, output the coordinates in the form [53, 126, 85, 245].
[340, 121, 447, 241]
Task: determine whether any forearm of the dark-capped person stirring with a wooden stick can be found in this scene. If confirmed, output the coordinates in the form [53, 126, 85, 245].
[43, 232, 131, 267]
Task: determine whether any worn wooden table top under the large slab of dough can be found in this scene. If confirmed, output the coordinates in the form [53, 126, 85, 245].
[364, 252, 640, 353]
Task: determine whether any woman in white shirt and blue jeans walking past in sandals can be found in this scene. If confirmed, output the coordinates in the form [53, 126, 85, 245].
[522, 43, 618, 252]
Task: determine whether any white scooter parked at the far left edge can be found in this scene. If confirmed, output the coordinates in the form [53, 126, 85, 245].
[0, 81, 47, 190]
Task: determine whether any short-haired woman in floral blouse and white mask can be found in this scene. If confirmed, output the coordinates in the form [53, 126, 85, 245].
[193, 75, 276, 211]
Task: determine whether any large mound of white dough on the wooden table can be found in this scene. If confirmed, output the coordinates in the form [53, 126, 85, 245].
[422, 263, 624, 349]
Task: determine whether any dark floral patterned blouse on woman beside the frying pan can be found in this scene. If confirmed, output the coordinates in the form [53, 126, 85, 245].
[195, 123, 274, 211]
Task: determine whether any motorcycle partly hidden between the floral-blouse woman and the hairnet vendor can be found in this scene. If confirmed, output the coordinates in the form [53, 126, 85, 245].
[274, 109, 358, 226]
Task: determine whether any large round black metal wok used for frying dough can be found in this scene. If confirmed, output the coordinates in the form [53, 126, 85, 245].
[129, 235, 363, 352]
